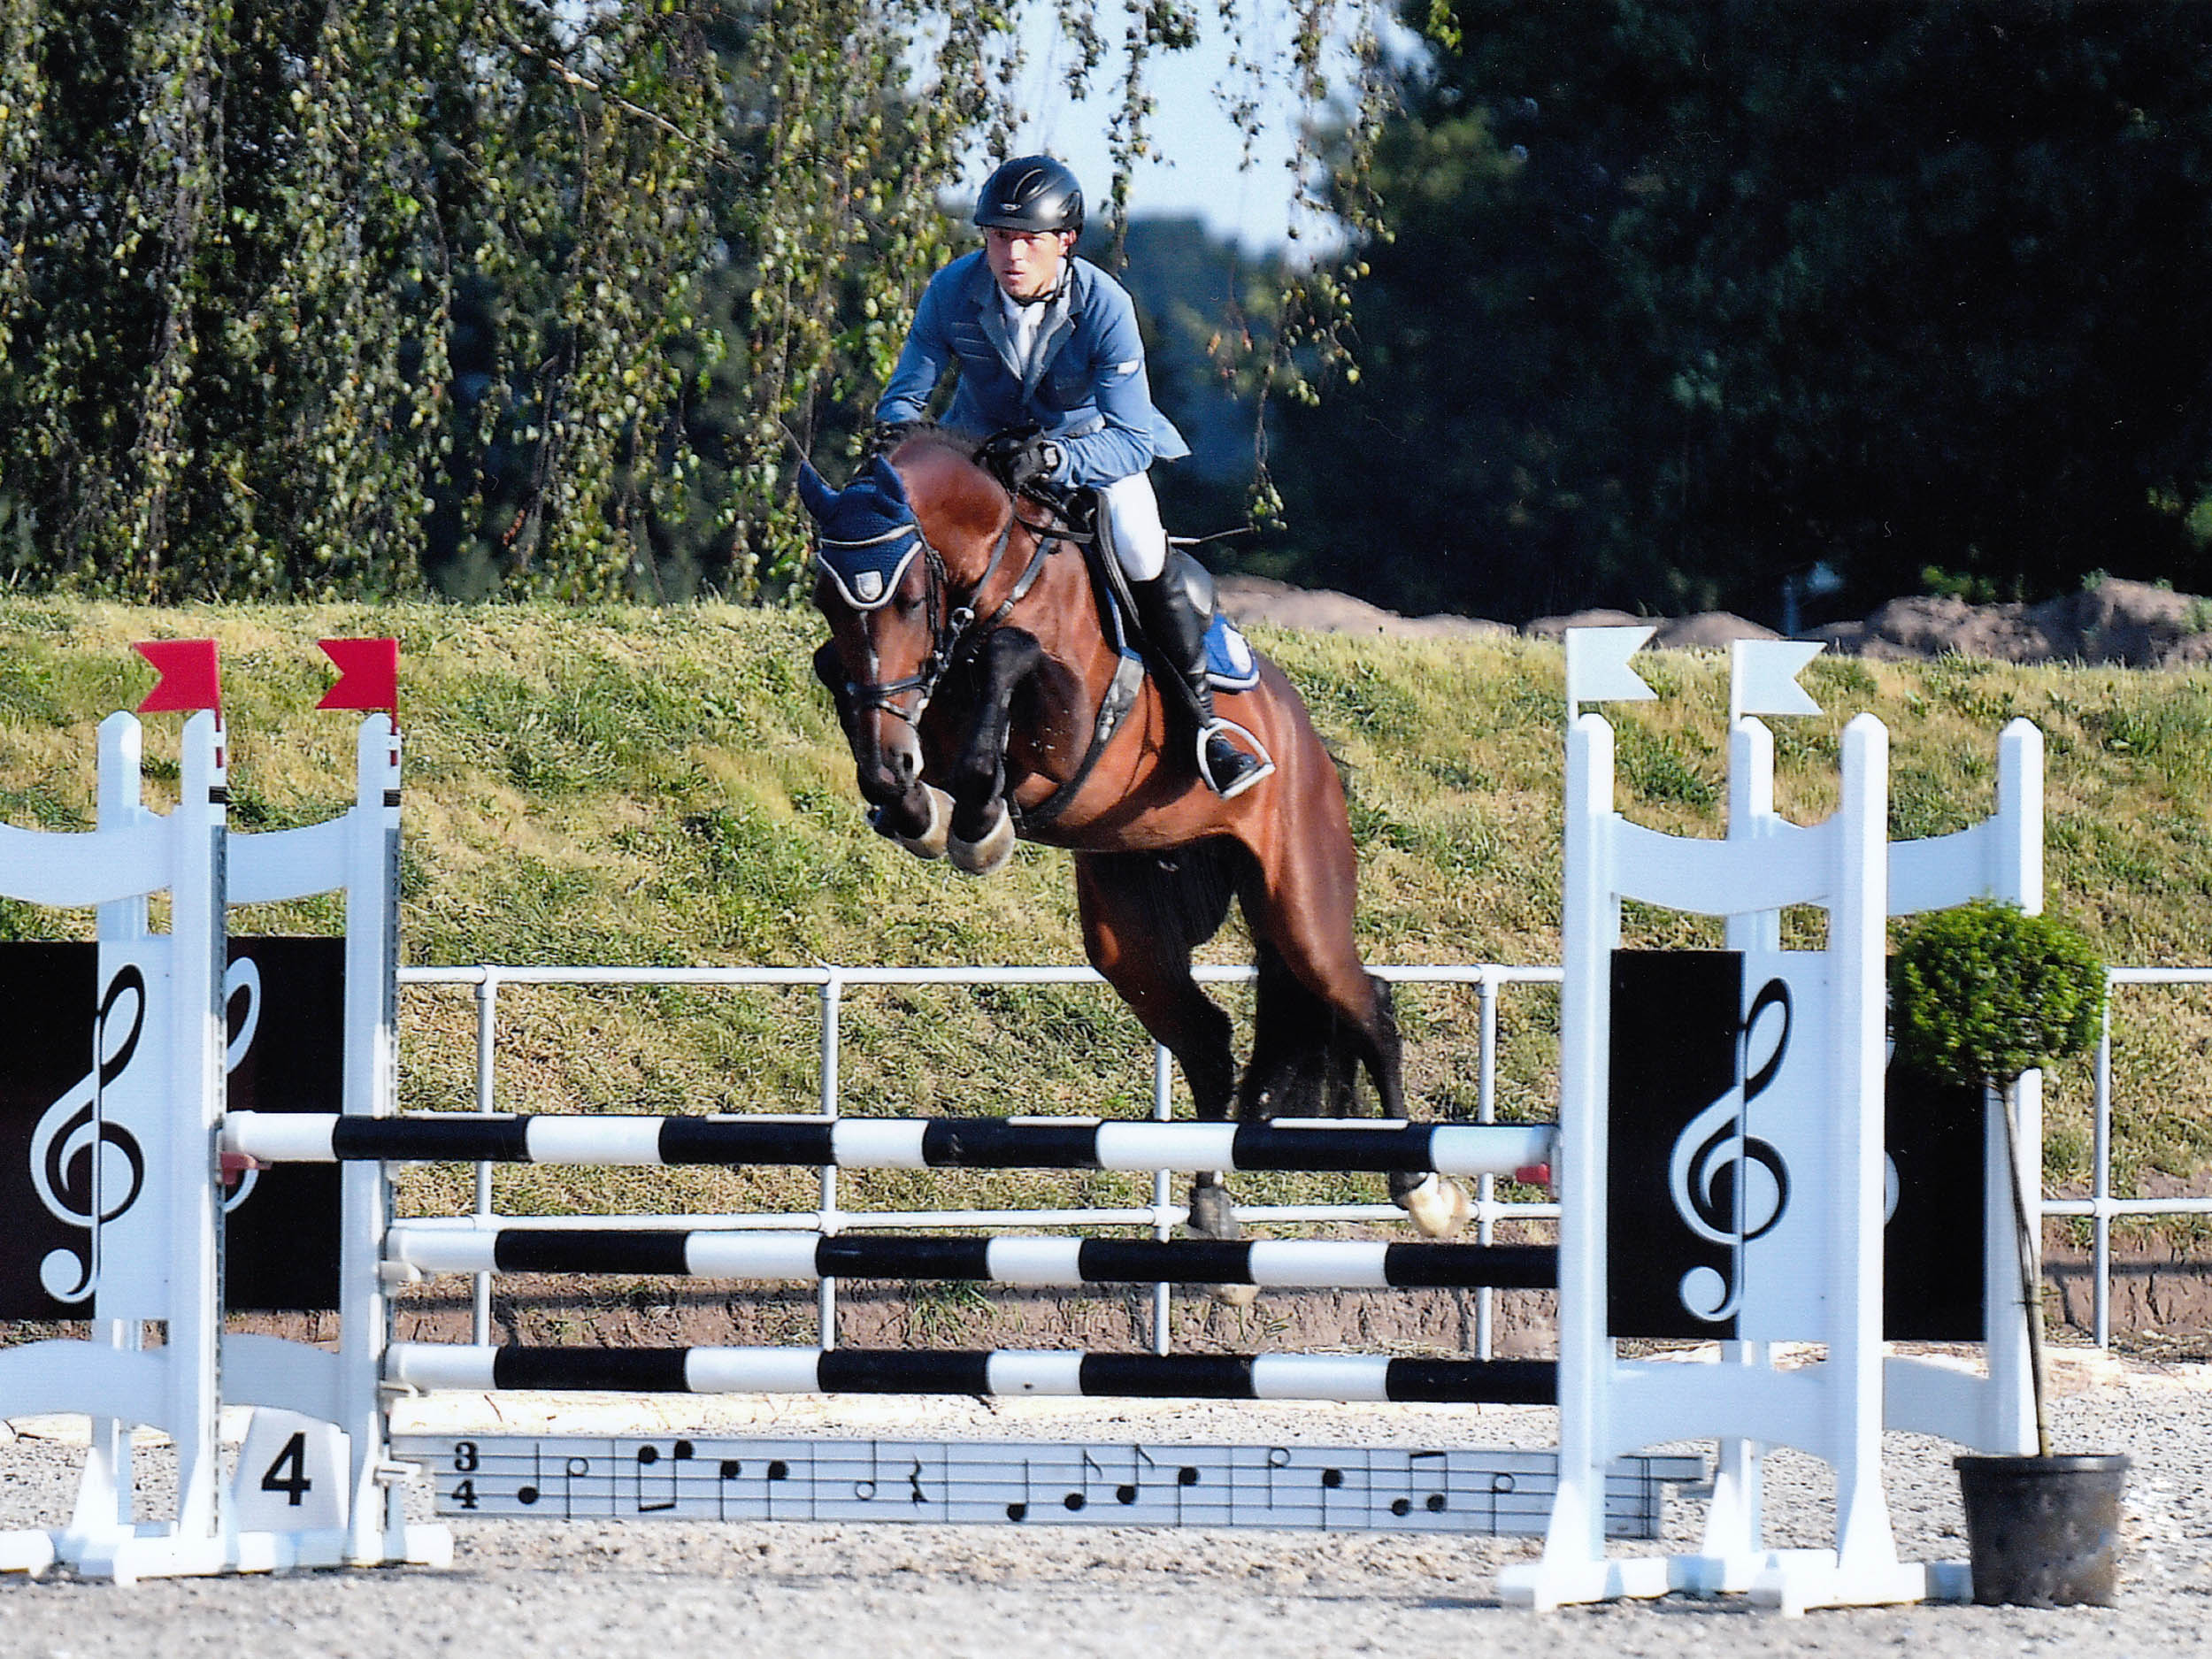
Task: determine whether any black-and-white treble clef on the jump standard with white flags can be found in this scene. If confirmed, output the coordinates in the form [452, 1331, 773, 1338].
[1668, 980, 1790, 1323]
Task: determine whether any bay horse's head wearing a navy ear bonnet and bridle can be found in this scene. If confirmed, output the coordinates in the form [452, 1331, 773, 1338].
[799, 441, 1007, 839]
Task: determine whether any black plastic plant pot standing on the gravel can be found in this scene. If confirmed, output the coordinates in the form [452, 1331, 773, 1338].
[1954, 1454, 2128, 1609]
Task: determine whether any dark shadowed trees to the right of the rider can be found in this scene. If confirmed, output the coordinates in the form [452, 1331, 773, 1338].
[1270, 0, 2212, 622]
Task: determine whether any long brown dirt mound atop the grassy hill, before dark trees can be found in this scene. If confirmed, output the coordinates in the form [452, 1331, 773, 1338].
[1221, 575, 2212, 668]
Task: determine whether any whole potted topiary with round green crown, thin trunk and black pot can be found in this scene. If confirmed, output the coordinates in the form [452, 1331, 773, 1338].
[1889, 901, 2128, 1606]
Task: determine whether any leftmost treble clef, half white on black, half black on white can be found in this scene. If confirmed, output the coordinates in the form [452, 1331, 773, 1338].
[31, 963, 146, 1303]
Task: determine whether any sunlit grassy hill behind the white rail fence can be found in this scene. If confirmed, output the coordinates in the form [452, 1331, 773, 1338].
[0, 602, 2212, 1239]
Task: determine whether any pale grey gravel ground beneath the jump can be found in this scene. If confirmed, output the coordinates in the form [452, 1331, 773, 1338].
[0, 1361, 2212, 1659]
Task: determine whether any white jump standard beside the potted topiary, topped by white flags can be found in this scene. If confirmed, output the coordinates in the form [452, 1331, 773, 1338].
[1500, 631, 2042, 1613]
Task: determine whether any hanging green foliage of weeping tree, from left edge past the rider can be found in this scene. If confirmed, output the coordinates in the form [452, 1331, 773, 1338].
[0, 0, 1385, 604]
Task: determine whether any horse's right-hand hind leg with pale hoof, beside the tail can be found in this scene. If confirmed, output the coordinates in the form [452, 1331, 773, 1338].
[1239, 823, 1473, 1239]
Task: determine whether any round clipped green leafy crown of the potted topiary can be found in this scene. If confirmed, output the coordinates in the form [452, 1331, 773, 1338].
[1892, 898, 2104, 1088]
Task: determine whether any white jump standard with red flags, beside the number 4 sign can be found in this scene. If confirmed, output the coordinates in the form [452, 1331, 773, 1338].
[0, 710, 451, 1582]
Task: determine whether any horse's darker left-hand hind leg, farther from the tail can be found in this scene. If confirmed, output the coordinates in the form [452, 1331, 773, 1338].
[1075, 848, 1255, 1305]
